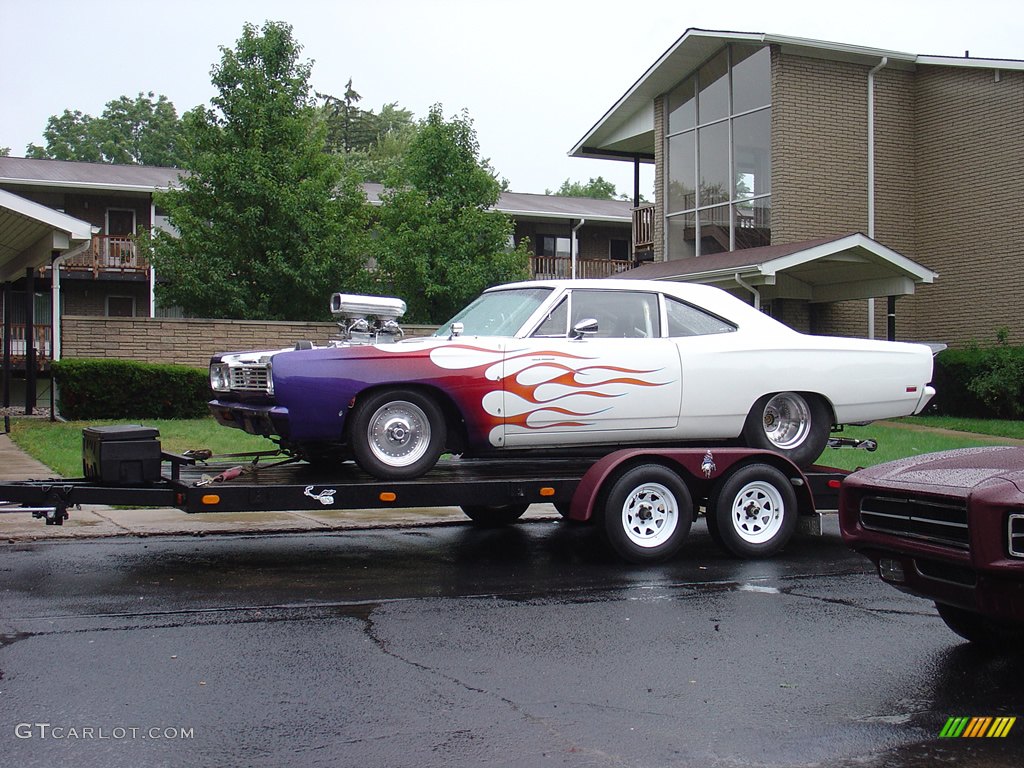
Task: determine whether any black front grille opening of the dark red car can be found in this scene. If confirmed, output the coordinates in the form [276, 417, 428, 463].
[860, 496, 966, 550]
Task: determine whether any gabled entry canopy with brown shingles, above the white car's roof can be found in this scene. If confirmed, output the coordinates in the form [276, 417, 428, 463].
[615, 232, 938, 304]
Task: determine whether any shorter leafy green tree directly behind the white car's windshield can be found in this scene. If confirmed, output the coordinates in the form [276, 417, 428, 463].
[374, 104, 528, 323]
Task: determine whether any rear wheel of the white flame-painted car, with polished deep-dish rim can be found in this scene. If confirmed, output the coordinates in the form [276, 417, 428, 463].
[743, 392, 831, 467]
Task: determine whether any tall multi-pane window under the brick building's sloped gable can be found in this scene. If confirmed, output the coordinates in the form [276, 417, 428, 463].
[664, 45, 771, 259]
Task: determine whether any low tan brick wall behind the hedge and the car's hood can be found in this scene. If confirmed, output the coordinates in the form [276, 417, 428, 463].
[60, 315, 435, 368]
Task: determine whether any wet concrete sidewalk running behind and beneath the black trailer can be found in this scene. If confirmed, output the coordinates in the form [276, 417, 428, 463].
[0, 434, 558, 544]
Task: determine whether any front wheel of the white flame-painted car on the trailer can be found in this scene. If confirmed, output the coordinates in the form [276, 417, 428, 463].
[349, 389, 445, 480]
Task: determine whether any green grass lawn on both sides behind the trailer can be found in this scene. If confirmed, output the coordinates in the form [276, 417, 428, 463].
[10, 417, 1024, 477]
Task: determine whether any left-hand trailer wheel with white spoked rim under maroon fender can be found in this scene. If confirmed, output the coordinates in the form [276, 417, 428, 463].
[602, 464, 693, 563]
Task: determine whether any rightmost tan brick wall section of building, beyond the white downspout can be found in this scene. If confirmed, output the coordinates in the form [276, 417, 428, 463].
[899, 67, 1024, 346]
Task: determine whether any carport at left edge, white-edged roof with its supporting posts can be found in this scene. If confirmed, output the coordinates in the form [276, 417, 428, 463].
[0, 189, 98, 414]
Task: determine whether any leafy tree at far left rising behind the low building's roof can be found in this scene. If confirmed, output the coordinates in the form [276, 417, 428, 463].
[26, 91, 181, 166]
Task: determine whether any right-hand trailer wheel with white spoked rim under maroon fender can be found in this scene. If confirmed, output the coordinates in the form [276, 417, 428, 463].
[708, 464, 798, 558]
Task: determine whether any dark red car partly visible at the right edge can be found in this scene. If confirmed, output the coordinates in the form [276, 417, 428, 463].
[840, 446, 1024, 649]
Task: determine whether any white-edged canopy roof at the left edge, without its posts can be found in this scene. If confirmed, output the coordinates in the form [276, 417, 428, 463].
[0, 189, 98, 283]
